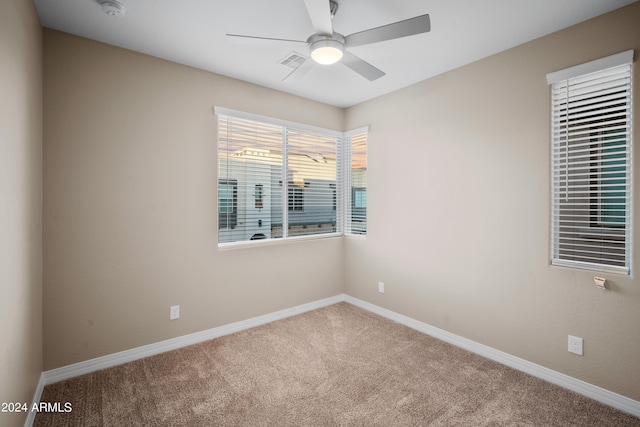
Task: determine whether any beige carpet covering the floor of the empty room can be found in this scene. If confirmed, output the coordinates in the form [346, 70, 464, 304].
[34, 303, 640, 427]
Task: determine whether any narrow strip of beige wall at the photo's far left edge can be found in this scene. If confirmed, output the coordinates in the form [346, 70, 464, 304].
[0, 0, 42, 426]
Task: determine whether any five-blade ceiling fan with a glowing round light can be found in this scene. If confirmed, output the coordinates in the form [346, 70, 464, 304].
[227, 0, 431, 81]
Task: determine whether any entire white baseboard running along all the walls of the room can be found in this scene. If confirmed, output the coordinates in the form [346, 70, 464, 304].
[38, 294, 640, 420]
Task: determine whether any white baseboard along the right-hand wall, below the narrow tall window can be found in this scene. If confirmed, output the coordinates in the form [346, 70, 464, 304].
[345, 295, 640, 418]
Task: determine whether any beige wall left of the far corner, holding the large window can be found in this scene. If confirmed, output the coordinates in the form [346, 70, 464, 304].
[43, 30, 344, 370]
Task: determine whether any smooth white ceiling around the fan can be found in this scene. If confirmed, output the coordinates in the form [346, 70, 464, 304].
[34, 0, 636, 107]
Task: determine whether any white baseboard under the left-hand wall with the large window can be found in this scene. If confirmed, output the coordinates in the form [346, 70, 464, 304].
[42, 294, 345, 385]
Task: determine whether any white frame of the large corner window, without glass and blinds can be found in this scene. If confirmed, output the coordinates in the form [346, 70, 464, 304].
[214, 106, 368, 249]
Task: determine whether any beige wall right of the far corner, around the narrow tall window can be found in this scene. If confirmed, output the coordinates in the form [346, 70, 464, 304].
[345, 3, 640, 400]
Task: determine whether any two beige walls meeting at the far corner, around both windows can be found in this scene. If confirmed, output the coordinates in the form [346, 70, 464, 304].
[43, 3, 640, 408]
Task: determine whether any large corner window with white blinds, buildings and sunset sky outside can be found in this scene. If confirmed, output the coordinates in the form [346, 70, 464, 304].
[216, 108, 366, 245]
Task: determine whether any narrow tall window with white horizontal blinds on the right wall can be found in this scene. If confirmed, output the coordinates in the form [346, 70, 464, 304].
[547, 51, 633, 274]
